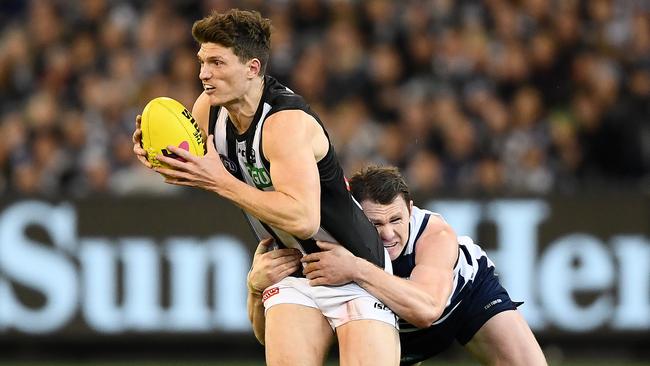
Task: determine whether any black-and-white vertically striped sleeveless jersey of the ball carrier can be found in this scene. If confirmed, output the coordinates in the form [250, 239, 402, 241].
[209, 76, 385, 268]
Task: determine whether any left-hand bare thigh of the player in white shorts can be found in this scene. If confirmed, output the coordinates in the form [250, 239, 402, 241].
[264, 304, 334, 366]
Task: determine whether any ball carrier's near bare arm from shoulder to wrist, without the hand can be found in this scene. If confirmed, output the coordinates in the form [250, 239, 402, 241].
[217, 111, 326, 239]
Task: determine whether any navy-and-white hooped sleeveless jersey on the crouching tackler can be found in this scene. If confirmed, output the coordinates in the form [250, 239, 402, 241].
[393, 206, 494, 332]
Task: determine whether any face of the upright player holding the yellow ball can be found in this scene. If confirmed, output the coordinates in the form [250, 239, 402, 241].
[196, 43, 254, 106]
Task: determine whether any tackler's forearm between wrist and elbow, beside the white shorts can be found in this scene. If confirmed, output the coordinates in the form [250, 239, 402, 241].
[354, 258, 445, 328]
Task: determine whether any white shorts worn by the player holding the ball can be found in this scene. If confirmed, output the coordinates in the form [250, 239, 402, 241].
[262, 250, 398, 330]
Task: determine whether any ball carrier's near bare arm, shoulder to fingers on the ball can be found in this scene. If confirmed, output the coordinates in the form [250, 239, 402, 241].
[155, 111, 327, 239]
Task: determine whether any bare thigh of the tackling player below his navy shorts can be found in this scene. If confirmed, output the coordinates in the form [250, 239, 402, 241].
[465, 310, 546, 366]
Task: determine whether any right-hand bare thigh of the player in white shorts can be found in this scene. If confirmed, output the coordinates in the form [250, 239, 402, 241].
[336, 320, 400, 366]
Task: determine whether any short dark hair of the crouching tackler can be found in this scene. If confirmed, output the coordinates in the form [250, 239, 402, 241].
[349, 165, 411, 205]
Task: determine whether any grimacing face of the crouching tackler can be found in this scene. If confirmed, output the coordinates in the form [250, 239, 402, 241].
[361, 195, 413, 260]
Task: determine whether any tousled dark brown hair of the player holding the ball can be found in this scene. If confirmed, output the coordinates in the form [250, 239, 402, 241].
[192, 9, 271, 75]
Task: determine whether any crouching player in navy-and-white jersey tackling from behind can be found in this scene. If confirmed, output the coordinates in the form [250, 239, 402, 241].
[249, 167, 546, 366]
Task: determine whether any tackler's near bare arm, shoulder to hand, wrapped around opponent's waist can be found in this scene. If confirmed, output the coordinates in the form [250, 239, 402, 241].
[302, 218, 458, 328]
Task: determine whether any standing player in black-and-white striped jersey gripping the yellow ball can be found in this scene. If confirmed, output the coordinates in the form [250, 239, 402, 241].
[133, 10, 399, 365]
